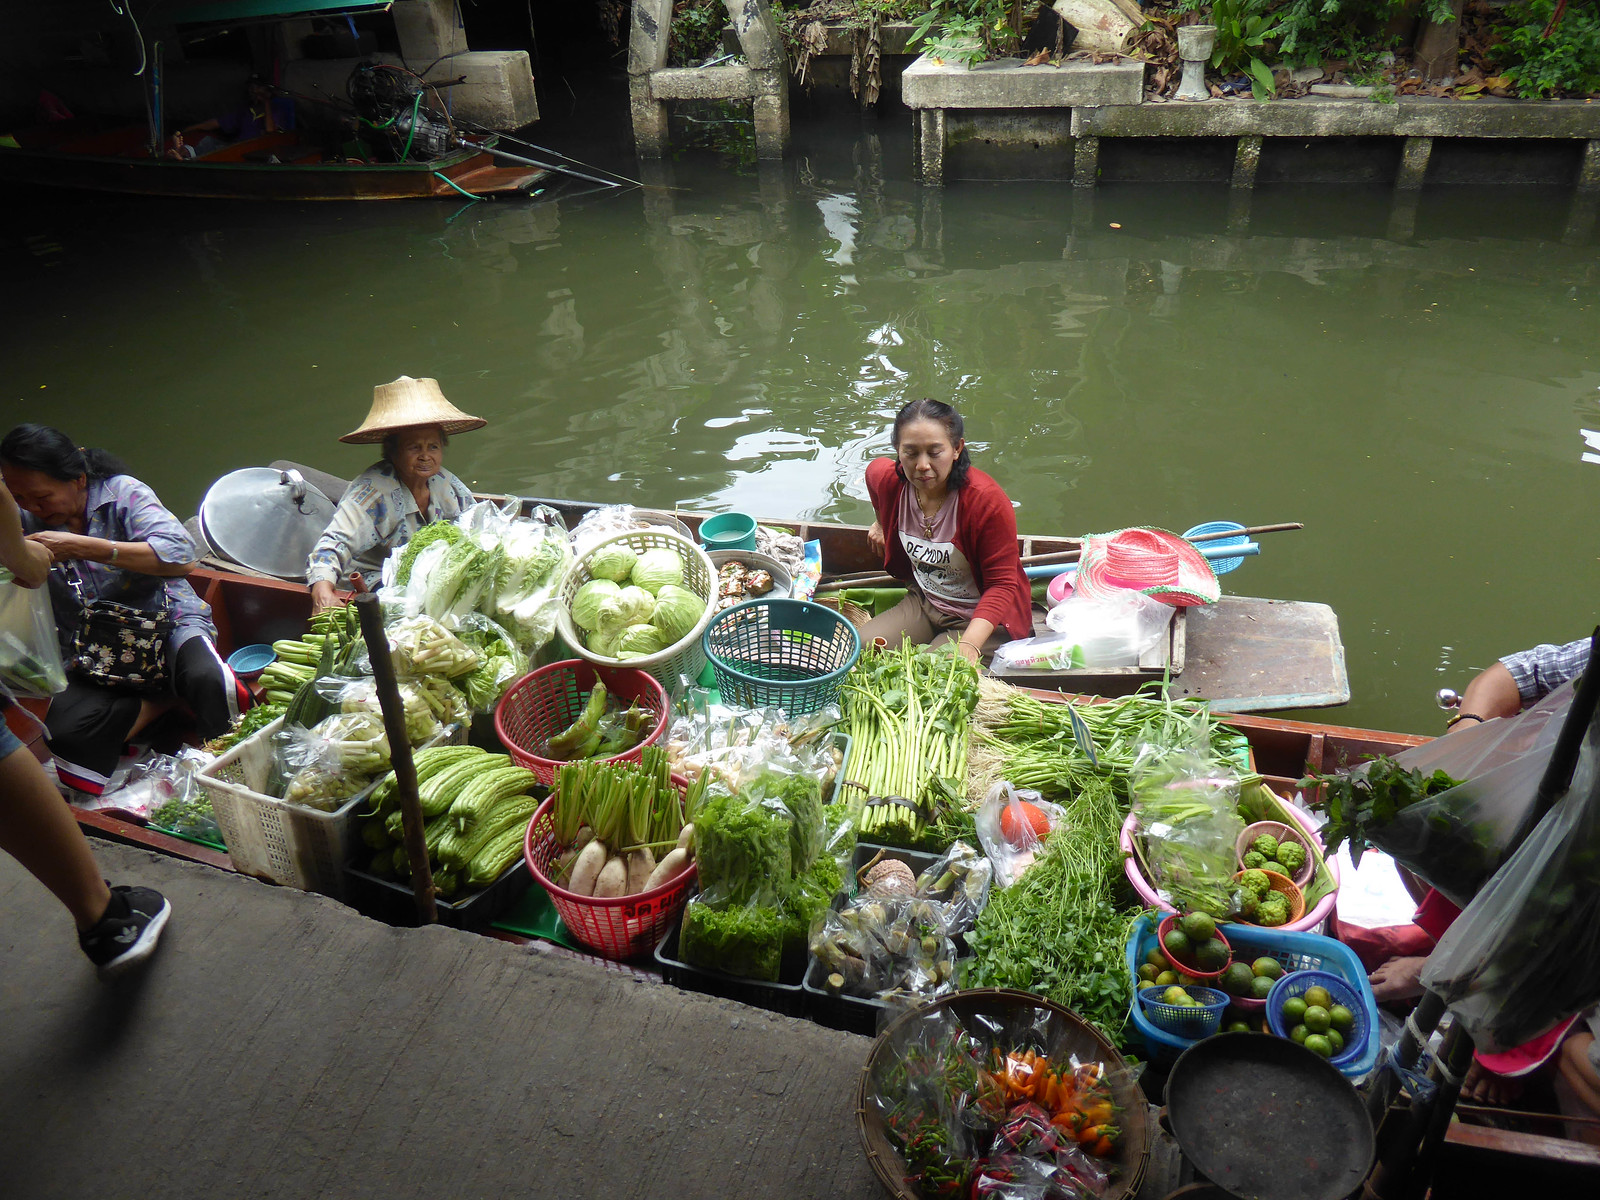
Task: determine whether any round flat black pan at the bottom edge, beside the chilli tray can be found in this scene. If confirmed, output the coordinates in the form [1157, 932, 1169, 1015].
[1166, 1034, 1373, 1200]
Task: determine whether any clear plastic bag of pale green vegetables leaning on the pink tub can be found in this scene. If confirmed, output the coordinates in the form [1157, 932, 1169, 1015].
[1128, 744, 1245, 920]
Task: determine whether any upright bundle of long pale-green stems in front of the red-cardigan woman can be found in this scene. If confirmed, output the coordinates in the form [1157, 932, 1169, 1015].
[842, 642, 978, 846]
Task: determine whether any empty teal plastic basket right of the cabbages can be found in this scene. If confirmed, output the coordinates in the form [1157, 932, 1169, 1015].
[701, 600, 861, 717]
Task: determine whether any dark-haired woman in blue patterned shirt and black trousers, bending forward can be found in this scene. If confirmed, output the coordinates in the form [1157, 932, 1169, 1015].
[0, 424, 250, 795]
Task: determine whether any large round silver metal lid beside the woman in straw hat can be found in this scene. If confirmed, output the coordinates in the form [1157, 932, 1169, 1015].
[200, 467, 334, 579]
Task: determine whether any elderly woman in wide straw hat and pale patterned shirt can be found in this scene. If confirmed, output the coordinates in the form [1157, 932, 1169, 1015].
[306, 374, 488, 611]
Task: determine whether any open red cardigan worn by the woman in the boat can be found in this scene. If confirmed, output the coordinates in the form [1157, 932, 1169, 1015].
[867, 458, 1034, 637]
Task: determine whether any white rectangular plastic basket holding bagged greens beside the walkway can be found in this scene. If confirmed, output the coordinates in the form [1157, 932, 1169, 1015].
[200, 717, 462, 899]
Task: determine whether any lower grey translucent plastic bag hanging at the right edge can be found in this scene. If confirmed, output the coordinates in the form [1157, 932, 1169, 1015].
[1422, 700, 1600, 1051]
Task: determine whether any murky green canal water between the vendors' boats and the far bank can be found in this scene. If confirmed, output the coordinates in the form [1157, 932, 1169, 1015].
[0, 126, 1600, 733]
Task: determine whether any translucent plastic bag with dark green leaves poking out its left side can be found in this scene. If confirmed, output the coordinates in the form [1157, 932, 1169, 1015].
[1350, 683, 1573, 906]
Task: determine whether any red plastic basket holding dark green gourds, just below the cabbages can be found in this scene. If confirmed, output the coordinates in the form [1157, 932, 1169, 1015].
[494, 658, 670, 787]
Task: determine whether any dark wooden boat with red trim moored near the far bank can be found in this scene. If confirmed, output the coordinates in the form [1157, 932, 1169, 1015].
[0, 122, 549, 200]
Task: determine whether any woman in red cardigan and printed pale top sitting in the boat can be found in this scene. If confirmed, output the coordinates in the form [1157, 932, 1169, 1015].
[861, 400, 1034, 662]
